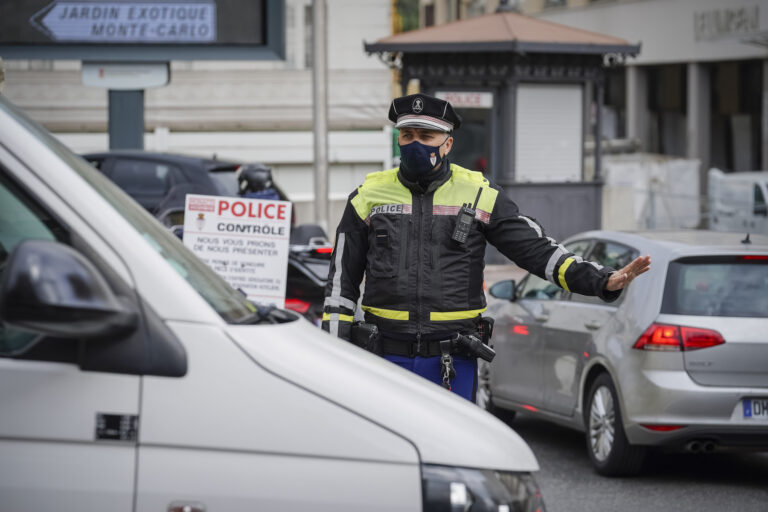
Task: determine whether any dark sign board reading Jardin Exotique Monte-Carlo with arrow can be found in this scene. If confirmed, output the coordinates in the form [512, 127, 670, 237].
[0, 0, 285, 61]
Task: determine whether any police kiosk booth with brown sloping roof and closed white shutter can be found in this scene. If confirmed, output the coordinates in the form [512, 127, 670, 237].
[365, 12, 640, 238]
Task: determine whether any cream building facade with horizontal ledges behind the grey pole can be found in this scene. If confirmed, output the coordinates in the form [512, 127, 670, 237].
[0, 0, 392, 227]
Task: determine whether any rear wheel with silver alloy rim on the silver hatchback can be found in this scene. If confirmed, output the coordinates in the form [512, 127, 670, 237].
[585, 373, 647, 476]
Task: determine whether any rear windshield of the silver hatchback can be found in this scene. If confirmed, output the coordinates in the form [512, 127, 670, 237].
[661, 255, 768, 318]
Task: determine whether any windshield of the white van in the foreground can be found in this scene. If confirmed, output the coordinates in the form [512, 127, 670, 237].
[0, 100, 255, 323]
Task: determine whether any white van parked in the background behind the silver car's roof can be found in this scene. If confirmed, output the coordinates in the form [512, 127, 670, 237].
[708, 169, 768, 235]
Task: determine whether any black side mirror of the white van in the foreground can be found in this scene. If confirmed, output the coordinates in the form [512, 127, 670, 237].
[0, 240, 138, 338]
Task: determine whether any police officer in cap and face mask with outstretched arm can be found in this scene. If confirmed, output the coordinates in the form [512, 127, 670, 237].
[322, 94, 650, 400]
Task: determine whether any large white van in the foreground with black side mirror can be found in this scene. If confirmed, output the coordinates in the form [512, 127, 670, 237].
[0, 97, 543, 512]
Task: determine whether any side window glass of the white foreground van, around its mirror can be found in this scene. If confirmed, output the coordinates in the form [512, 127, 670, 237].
[0, 168, 68, 356]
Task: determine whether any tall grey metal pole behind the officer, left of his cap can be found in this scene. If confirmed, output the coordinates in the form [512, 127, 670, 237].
[312, 0, 328, 232]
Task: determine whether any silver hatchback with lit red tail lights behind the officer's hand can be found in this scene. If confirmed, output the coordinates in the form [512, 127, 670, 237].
[481, 231, 768, 475]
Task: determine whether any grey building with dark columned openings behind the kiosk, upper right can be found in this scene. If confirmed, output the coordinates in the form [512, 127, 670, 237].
[420, 0, 768, 199]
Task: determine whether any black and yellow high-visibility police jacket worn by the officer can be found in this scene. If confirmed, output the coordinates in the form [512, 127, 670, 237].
[322, 162, 620, 339]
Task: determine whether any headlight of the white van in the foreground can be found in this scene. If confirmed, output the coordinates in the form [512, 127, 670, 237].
[421, 464, 545, 512]
